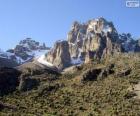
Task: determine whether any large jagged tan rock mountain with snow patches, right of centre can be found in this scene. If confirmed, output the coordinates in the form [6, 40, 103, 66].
[45, 17, 140, 69]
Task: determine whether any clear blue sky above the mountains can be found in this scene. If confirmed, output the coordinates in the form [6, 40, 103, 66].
[0, 0, 140, 50]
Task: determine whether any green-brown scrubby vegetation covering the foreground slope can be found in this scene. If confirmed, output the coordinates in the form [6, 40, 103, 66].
[0, 54, 140, 116]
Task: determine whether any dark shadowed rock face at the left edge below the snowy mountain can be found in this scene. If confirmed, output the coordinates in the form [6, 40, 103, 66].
[0, 68, 21, 96]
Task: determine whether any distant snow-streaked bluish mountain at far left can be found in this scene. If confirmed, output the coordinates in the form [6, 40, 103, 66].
[0, 38, 50, 66]
